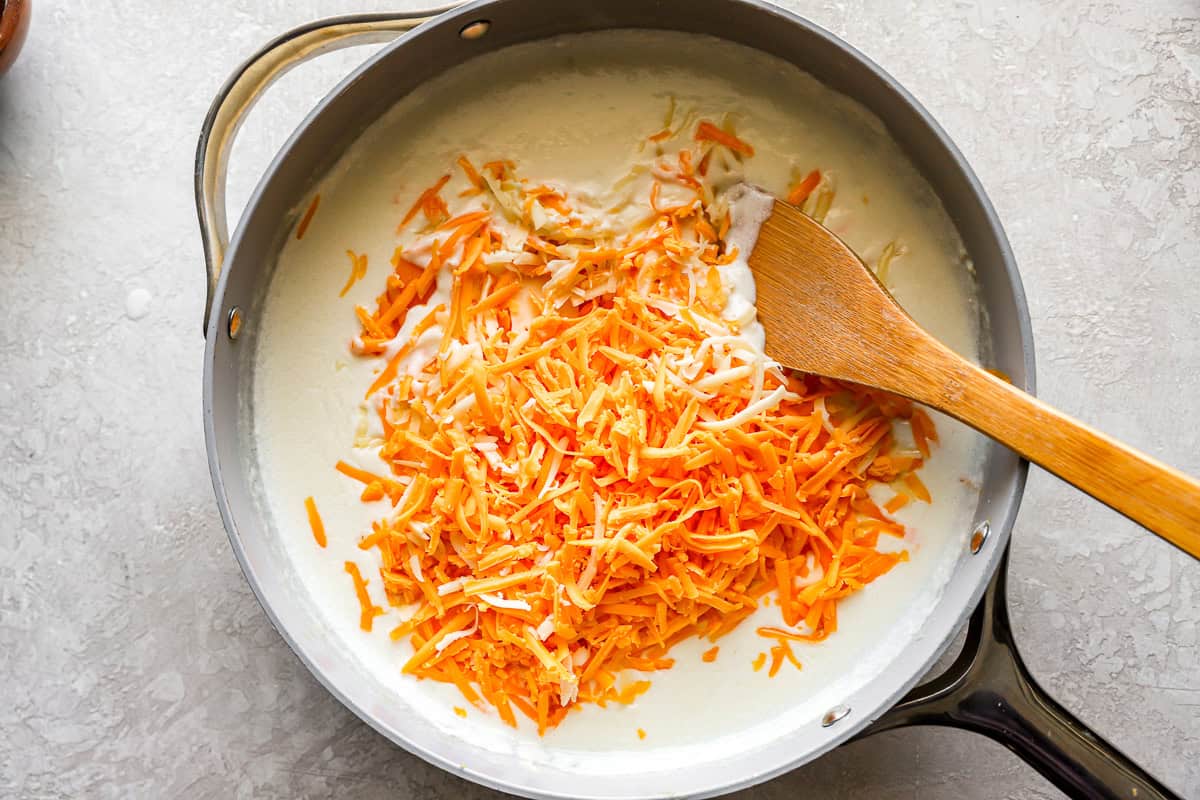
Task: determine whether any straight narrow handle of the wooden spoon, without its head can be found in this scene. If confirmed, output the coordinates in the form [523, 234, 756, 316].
[894, 338, 1200, 559]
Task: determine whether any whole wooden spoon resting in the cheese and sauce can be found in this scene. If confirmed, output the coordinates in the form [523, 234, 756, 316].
[731, 187, 1200, 559]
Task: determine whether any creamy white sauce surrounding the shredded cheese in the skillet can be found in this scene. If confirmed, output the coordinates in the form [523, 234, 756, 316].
[252, 31, 983, 772]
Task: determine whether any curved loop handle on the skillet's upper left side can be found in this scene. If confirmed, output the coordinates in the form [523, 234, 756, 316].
[196, 8, 445, 331]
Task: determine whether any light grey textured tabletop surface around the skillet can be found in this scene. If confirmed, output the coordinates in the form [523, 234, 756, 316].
[0, 0, 1200, 799]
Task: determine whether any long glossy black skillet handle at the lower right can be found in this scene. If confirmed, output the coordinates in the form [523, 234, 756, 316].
[860, 552, 1178, 800]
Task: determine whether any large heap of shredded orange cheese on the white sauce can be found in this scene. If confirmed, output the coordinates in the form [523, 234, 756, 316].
[337, 110, 936, 738]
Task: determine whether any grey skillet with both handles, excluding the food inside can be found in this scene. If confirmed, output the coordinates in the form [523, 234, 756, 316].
[196, 0, 1174, 798]
